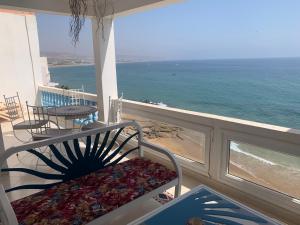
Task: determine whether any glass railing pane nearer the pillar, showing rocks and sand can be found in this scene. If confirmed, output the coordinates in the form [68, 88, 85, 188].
[122, 114, 205, 163]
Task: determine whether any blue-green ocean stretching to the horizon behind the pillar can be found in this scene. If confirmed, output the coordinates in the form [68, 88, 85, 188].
[50, 58, 300, 129]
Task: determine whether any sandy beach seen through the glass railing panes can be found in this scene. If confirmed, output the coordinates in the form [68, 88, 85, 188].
[123, 115, 300, 199]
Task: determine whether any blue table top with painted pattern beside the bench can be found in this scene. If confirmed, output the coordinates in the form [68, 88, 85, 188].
[141, 186, 279, 225]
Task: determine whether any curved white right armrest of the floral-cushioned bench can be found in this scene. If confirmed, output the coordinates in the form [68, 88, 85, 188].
[140, 141, 182, 185]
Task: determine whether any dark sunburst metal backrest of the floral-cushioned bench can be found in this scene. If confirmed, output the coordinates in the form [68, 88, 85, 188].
[0, 122, 142, 192]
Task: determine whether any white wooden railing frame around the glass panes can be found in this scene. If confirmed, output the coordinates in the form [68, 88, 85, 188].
[123, 100, 300, 215]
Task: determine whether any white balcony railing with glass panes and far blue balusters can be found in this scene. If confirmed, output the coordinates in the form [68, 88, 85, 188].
[40, 87, 300, 214]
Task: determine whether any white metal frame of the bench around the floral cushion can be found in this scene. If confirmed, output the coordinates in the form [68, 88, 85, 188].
[0, 121, 182, 225]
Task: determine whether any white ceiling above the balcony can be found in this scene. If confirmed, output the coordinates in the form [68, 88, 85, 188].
[0, 0, 183, 16]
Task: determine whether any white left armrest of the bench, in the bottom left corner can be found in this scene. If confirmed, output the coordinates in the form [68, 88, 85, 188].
[0, 184, 19, 225]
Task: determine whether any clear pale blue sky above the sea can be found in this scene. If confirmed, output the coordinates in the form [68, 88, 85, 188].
[37, 0, 300, 60]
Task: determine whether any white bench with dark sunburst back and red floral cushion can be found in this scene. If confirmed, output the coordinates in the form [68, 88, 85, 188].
[0, 122, 182, 225]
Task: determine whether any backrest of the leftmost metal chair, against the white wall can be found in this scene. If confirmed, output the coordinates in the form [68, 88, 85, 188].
[3, 92, 25, 122]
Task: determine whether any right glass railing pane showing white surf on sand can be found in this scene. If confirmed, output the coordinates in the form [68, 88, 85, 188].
[228, 141, 300, 199]
